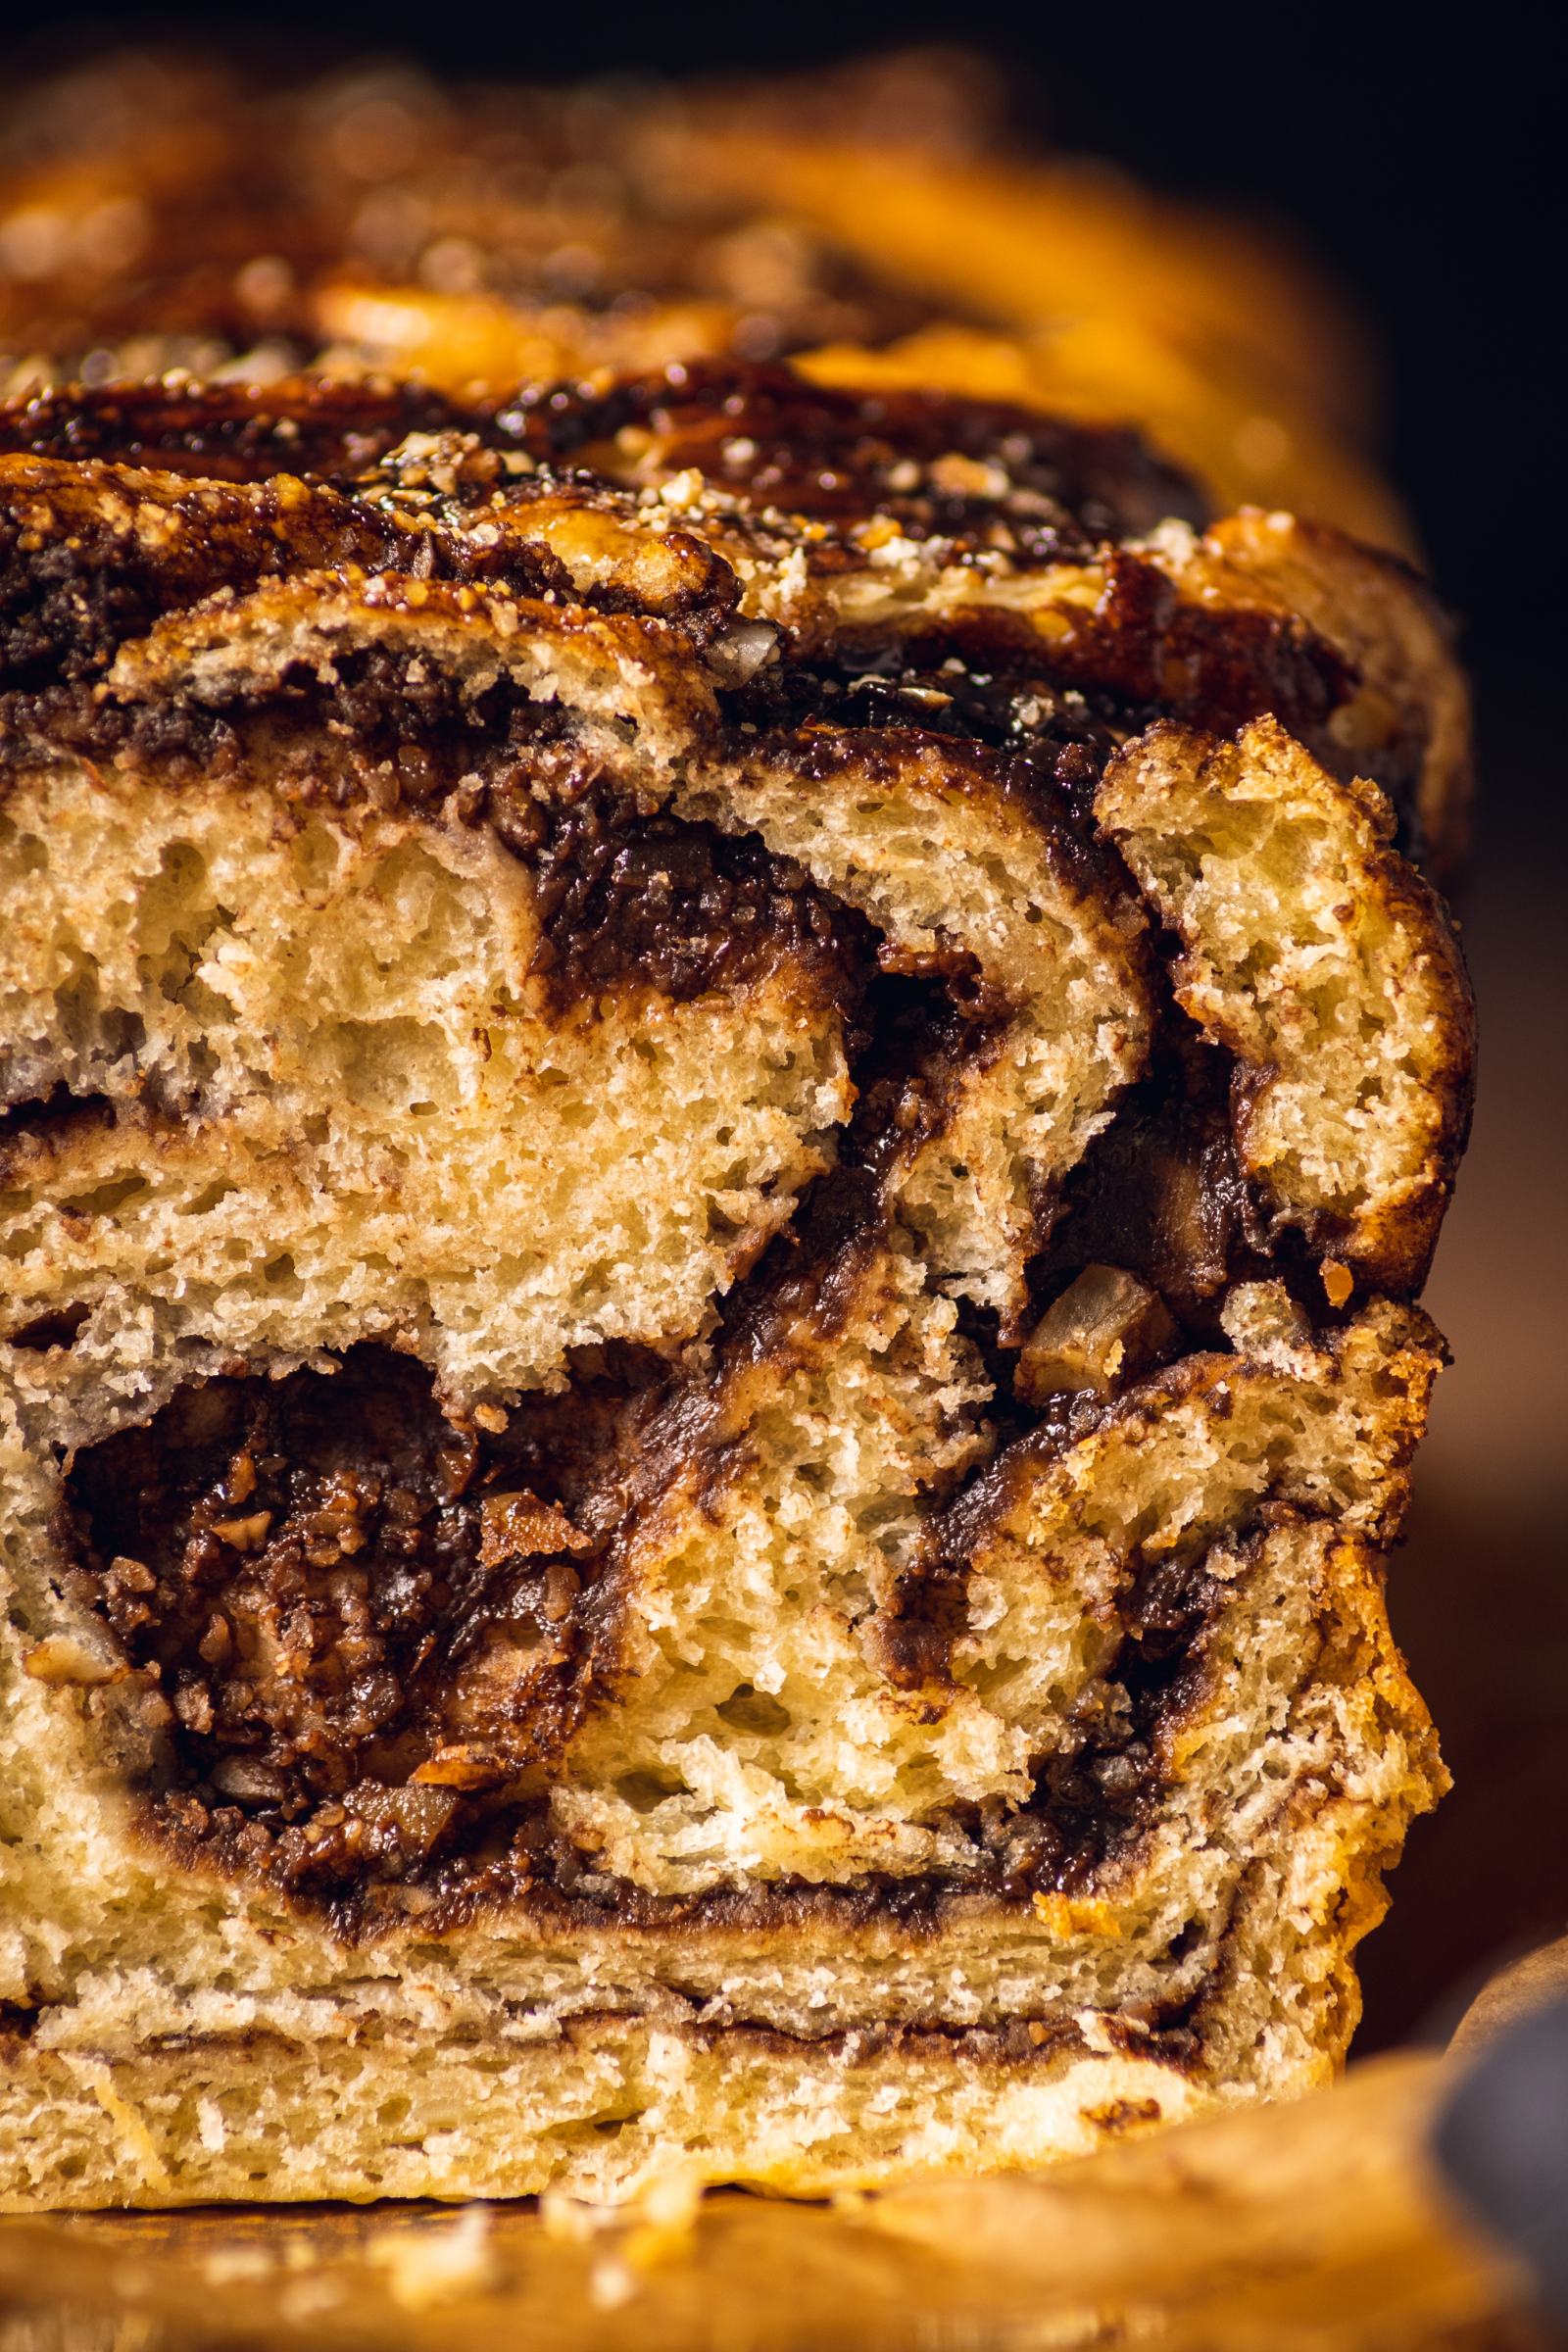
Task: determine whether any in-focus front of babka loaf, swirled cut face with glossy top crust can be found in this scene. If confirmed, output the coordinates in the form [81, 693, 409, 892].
[0, 369, 1469, 2206]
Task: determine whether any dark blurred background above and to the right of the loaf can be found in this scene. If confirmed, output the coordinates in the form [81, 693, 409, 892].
[12, 0, 1568, 2048]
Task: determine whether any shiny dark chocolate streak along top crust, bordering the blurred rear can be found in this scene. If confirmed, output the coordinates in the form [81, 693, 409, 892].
[0, 360, 1208, 546]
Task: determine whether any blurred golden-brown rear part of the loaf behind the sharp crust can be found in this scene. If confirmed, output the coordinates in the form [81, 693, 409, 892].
[0, 52, 1405, 546]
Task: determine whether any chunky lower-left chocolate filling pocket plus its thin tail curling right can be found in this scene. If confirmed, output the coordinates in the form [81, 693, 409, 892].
[59, 1346, 1222, 1936]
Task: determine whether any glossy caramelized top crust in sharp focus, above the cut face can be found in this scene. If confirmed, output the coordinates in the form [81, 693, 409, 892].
[0, 365, 1462, 849]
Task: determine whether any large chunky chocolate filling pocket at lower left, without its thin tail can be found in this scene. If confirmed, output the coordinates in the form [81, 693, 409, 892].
[61, 1346, 656, 1886]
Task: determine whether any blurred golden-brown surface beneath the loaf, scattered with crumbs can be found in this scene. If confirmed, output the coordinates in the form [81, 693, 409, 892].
[0, 1962, 1561, 2352]
